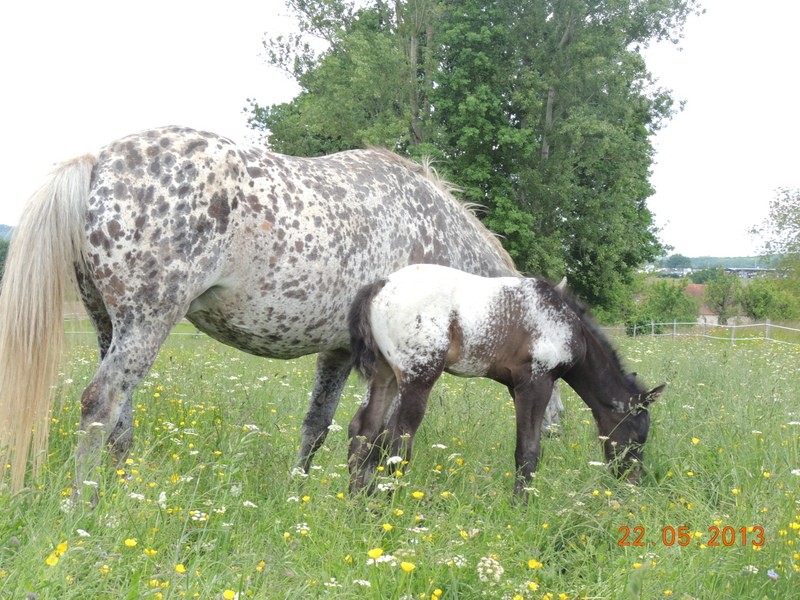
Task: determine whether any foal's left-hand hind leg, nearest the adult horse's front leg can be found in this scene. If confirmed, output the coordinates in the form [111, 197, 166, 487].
[349, 361, 399, 494]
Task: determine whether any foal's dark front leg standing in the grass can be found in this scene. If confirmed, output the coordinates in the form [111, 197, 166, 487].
[510, 376, 553, 502]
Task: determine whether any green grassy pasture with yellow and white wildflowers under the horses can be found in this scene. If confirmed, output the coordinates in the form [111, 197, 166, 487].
[0, 334, 800, 599]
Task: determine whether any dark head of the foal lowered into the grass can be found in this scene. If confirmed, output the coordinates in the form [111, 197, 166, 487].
[601, 385, 666, 483]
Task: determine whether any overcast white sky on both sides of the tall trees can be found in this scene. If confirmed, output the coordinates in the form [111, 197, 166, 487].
[0, 0, 800, 256]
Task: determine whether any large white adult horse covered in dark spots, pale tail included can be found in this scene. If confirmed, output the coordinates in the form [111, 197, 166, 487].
[0, 127, 564, 490]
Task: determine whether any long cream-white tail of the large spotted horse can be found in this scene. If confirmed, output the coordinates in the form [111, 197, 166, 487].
[0, 155, 97, 492]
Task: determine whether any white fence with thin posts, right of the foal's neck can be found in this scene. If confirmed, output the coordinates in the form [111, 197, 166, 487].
[602, 321, 800, 346]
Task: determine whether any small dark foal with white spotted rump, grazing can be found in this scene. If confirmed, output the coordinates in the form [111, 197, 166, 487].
[349, 264, 664, 501]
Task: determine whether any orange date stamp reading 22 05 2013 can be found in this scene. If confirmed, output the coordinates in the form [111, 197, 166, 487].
[617, 525, 766, 547]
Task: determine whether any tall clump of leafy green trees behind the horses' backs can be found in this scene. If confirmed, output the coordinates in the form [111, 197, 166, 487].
[251, 0, 697, 312]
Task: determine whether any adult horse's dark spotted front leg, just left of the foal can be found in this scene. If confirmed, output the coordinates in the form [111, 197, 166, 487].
[296, 350, 350, 473]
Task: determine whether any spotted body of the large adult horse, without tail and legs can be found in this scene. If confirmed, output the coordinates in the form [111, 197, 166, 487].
[87, 127, 513, 358]
